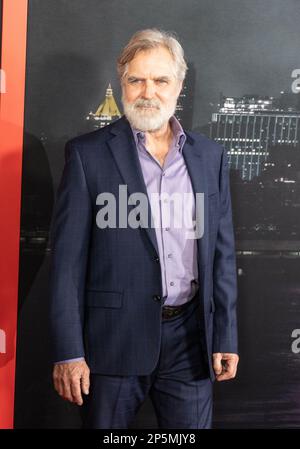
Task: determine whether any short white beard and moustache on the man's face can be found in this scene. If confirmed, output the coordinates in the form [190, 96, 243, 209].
[122, 95, 177, 132]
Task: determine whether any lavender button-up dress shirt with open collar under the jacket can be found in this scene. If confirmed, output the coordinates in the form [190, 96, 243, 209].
[132, 116, 198, 306]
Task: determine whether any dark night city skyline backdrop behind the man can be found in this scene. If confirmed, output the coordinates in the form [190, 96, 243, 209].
[0, 0, 300, 428]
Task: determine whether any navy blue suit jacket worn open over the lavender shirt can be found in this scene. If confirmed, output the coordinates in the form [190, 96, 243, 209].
[50, 116, 237, 379]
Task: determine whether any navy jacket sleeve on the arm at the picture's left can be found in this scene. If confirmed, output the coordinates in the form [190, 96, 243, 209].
[50, 142, 92, 362]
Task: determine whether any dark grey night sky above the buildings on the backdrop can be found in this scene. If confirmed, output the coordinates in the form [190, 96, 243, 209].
[25, 0, 300, 138]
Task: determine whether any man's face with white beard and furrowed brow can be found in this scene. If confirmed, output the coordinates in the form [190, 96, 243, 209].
[122, 47, 182, 131]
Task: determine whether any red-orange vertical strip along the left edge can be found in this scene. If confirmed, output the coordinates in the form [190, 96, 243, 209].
[0, 0, 27, 428]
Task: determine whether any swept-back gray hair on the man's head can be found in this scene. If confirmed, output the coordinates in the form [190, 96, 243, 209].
[117, 28, 187, 81]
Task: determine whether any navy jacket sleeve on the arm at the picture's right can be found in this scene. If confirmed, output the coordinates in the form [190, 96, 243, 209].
[213, 150, 238, 353]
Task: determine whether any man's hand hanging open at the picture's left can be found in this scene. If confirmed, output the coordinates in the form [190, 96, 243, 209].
[53, 360, 90, 405]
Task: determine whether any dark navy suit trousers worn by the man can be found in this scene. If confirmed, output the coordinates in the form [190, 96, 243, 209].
[81, 299, 212, 429]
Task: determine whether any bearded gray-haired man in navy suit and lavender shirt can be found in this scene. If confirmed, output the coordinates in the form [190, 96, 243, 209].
[50, 29, 238, 428]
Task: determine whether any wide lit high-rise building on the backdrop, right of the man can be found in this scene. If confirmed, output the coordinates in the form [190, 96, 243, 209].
[210, 95, 300, 181]
